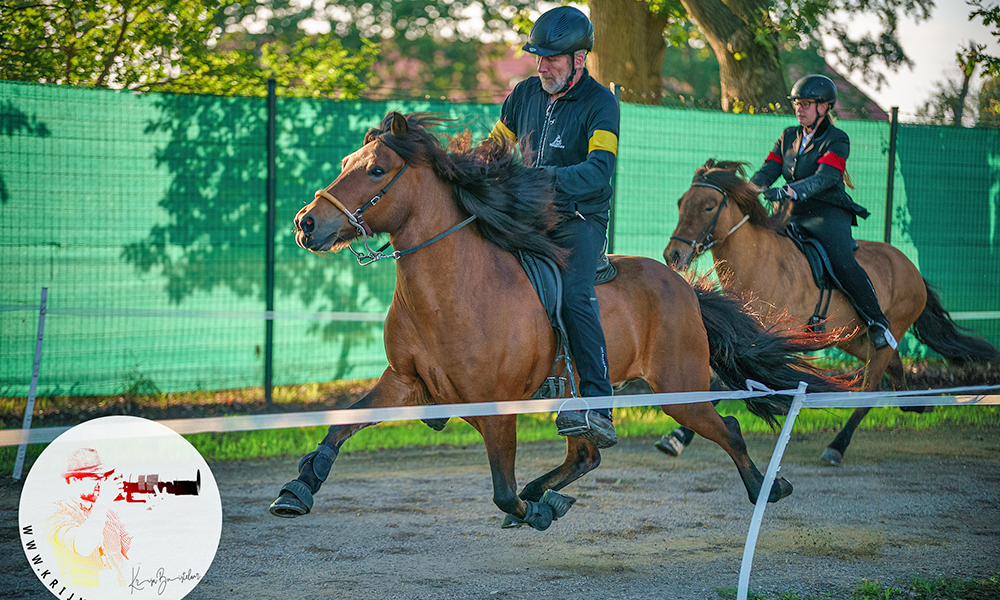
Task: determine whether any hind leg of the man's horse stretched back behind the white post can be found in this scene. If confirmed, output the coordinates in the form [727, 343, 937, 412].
[662, 402, 792, 503]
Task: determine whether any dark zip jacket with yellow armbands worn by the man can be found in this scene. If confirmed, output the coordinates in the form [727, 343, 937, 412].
[490, 69, 619, 222]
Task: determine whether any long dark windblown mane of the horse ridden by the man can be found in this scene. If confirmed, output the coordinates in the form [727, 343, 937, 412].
[365, 113, 567, 265]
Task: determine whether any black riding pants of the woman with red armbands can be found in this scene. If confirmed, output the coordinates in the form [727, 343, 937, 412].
[792, 201, 889, 326]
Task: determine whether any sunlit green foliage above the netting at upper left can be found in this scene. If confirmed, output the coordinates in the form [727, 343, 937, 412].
[0, 0, 377, 98]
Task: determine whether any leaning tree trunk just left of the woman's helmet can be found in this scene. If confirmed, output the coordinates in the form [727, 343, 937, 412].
[676, 0, 790, 112]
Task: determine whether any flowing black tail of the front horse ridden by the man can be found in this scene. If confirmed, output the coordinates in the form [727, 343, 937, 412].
[694, 281, 859, 428]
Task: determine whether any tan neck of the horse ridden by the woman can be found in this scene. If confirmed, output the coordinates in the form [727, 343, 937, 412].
[712, 220, 787, 297]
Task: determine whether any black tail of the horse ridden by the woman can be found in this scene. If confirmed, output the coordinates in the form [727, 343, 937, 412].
[912, 279, 1000, 364]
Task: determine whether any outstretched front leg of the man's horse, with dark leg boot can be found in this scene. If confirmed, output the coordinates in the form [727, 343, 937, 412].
[269, 369, 418, 518]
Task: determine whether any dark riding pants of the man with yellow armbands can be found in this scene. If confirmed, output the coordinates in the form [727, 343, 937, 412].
[552, 215, 612, 414]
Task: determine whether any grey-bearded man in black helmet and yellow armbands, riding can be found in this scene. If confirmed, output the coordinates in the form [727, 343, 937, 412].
[490, 6, 619, 448]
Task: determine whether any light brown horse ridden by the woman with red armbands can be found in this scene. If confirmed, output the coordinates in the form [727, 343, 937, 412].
[663, 160, 1000, 465]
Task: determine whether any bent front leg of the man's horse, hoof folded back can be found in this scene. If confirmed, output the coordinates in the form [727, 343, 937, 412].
[466, 415, 573, 531]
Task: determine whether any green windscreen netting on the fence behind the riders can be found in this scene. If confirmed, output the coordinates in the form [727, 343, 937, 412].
[0, 83, 1000, 396]
